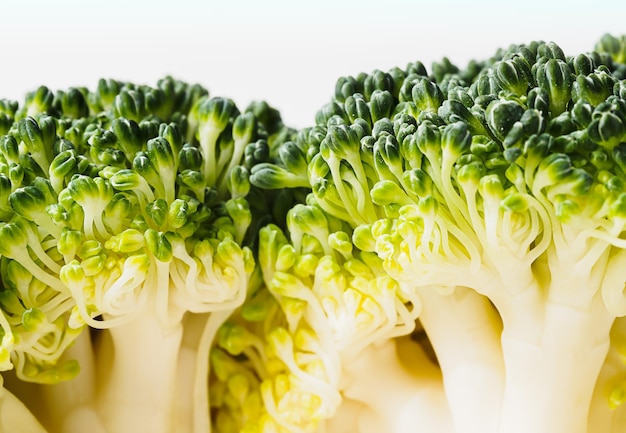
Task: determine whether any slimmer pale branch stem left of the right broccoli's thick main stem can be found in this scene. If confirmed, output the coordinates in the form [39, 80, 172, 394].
[419, 287, 504, 433]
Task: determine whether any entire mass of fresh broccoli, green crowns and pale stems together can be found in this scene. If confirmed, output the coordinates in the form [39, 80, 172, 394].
[0, 35, 626, 433]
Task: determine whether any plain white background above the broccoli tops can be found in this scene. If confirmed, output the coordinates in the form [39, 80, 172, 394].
[0, 0, 626, 127]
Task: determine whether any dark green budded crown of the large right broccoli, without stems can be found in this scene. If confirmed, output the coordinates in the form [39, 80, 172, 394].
[241, 35, 626, 428]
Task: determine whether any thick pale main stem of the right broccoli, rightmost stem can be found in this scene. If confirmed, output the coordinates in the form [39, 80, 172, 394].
[500, 302, 613, 433]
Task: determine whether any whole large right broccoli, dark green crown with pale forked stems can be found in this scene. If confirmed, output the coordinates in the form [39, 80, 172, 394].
[250, 35, 626, 433]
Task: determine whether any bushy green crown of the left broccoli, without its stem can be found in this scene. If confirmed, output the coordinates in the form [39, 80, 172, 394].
[0, 77, 289, 382]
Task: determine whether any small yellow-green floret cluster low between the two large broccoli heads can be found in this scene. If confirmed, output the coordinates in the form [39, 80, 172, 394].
[212, 199, 419, 432]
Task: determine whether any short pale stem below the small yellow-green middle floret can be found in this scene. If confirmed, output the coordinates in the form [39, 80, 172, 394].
[338, 337, 454, 433]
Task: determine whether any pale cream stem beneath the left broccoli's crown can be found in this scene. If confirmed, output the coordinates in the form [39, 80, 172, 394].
[97, 313, 183, 433]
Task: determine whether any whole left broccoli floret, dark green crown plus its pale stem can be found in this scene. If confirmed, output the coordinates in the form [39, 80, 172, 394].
[0, 77, 288, 432]
